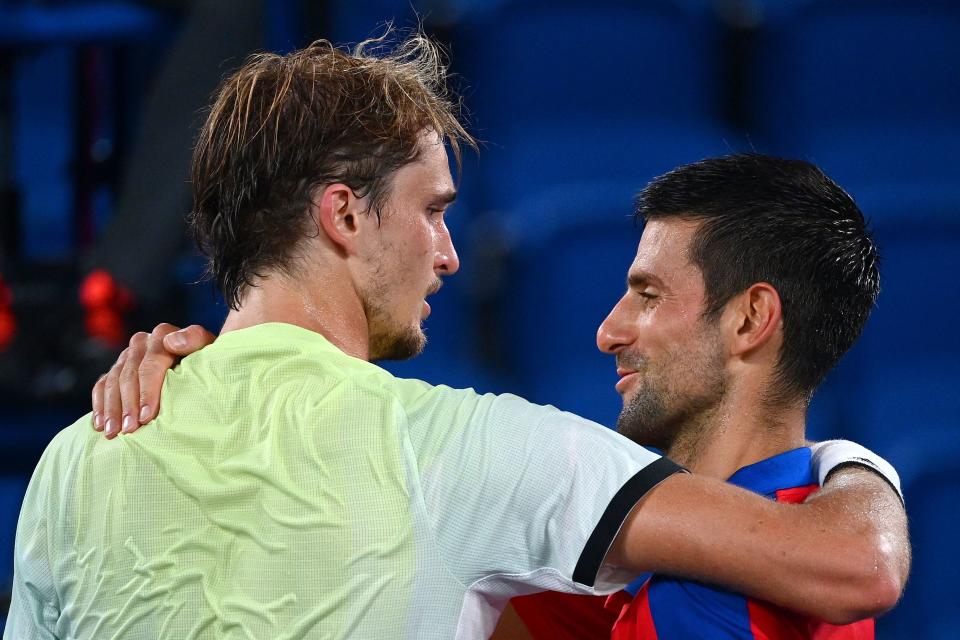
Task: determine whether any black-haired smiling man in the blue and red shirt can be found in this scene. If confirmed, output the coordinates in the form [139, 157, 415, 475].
[513, 155, 900, 640]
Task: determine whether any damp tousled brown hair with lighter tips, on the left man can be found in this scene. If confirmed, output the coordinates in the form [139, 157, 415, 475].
[190, 31, 475, 309]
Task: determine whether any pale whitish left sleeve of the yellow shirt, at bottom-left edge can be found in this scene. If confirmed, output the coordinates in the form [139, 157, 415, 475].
[3, 442, 59, 640]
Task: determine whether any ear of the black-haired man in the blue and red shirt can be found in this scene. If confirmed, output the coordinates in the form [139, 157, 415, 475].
[723, 282, 783, 355]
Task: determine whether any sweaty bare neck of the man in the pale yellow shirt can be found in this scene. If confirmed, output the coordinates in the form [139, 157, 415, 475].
[220, 273, 370, 360]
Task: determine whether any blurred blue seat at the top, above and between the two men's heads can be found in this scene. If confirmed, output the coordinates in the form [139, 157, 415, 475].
[455, 0, 734, 211]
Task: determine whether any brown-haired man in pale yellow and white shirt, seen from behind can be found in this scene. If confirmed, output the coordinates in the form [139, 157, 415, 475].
[7, 33, 907, 639]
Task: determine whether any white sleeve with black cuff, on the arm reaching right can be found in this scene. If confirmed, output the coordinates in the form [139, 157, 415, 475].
[404, 392, 680, 597]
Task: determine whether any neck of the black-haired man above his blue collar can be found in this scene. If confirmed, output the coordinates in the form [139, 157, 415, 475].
[666, 384, 806, 480]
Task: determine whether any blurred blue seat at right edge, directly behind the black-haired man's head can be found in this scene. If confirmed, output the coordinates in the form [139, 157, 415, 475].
[824, 185, 960, 451]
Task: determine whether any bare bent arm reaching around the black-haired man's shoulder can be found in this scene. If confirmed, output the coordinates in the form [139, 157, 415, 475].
[607, 466, 910, 624]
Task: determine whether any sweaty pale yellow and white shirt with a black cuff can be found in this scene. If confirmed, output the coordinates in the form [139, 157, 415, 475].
[4, 323, 675, 640]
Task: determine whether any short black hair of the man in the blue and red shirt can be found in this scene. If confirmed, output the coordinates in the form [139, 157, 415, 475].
[636, 154, 880, 399]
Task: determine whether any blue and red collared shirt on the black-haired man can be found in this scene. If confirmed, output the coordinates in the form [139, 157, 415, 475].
[511, 448, 874, 640]
